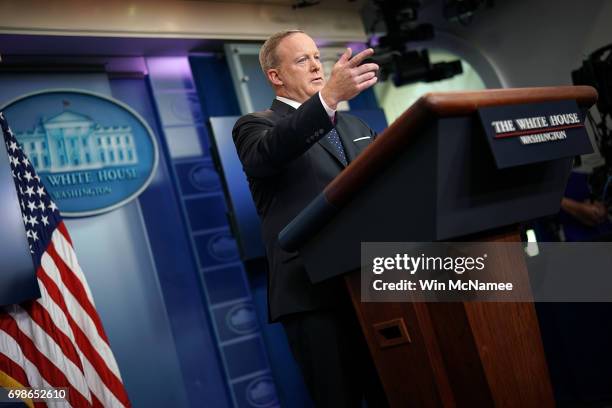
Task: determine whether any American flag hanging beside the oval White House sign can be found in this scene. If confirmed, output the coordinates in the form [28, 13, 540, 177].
[0, 112, 131, 407]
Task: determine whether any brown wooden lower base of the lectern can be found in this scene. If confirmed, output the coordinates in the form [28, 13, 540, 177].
[345, 230, 555, 408]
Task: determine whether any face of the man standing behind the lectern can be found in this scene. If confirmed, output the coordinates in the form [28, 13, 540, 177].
[268, 33, 325, 103]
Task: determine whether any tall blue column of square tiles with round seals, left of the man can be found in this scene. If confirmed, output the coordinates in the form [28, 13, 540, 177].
[147, 56, 278, 408]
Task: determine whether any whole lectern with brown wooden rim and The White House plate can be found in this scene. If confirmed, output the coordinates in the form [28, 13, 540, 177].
[279, 86, 597, 407]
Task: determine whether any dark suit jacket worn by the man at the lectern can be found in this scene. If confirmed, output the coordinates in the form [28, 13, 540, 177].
[232, 94, 375, 320]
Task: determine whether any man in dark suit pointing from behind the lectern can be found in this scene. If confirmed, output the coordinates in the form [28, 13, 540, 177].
[233, 30, 384, 407]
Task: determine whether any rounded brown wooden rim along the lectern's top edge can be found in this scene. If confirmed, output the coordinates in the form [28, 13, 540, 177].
[323, 86, 597, 208]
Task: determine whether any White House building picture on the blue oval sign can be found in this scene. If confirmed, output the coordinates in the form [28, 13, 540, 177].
[15, 110, 138, 173]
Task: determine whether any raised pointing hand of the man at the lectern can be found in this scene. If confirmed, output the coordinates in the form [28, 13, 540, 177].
[321, 48, 378, 109]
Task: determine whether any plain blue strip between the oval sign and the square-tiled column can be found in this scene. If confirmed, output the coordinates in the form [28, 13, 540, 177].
[110, 79, 227, 407]
